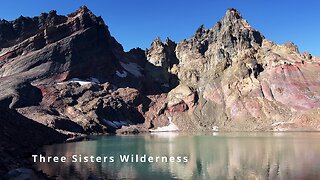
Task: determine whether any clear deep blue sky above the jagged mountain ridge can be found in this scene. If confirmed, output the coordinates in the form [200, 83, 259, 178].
[0, 0, 320, 56]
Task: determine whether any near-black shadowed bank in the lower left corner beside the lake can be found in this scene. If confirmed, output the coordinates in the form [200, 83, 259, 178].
[0, 108, 67, 177]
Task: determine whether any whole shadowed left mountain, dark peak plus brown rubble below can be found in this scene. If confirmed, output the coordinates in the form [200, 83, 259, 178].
[0, 7, 144, 133]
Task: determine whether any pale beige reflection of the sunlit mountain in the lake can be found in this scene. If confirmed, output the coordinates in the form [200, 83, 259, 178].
[146, 133, 320, 179]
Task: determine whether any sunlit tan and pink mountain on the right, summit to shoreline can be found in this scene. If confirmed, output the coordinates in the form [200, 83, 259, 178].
[147, 9, 320, 131]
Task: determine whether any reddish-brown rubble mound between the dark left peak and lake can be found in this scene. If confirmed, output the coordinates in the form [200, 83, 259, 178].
[19, 82, 144, 134]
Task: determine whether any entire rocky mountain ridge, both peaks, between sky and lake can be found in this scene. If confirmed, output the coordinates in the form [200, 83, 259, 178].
[0, 7, 320, 139]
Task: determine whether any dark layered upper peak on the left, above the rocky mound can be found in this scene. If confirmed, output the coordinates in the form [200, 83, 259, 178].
[0, 7, 129, 89]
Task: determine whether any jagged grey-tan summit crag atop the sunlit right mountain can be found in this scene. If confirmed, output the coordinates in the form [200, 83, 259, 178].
[176, 9, 264, 86]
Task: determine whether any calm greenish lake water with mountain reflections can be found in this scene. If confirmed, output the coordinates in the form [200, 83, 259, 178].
[35, 132, 320, 180]
